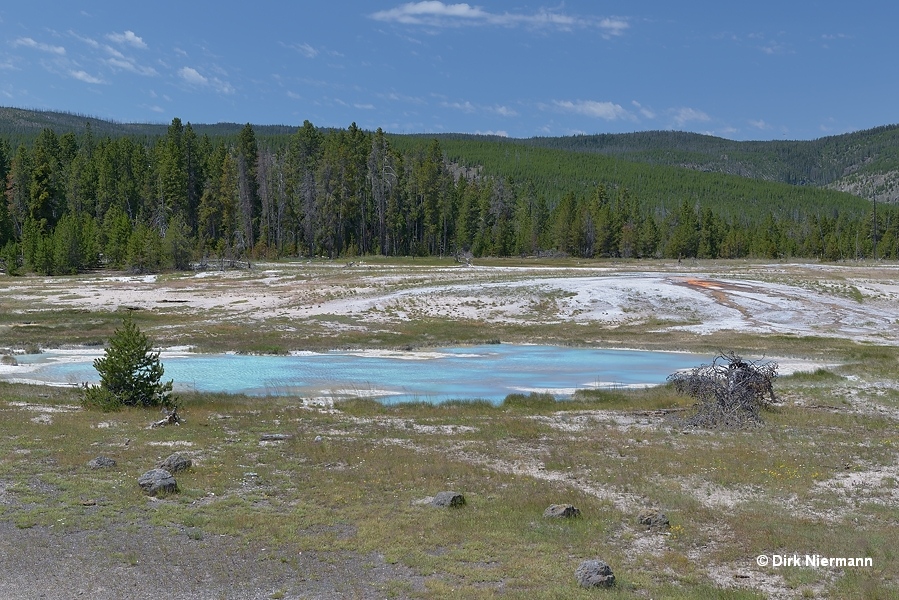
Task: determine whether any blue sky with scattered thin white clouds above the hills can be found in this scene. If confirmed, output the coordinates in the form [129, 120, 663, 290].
[0, 0, 899, 140]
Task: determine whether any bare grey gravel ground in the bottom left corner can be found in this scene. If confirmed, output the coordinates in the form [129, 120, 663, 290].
[0, 521, 422, 600]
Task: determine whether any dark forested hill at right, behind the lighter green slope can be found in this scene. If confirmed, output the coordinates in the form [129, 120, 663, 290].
[521, 125, 899, 202]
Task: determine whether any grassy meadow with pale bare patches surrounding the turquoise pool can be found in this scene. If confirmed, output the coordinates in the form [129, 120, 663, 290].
[0, 263, 899, 599]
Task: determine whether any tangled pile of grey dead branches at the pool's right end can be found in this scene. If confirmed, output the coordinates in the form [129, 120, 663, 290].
[668, 352, 777, 429]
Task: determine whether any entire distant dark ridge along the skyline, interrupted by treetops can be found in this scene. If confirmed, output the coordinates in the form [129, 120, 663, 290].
[0, 107, 899, 203]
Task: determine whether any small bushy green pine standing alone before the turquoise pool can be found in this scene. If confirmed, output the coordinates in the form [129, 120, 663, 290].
[83, 315, 175, 410]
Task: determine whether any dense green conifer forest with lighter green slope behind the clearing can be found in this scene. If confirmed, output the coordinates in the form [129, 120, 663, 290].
[0, 118, 899, 274]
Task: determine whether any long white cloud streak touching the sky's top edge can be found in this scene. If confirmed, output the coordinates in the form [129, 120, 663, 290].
[369, 0, 630, 38]
